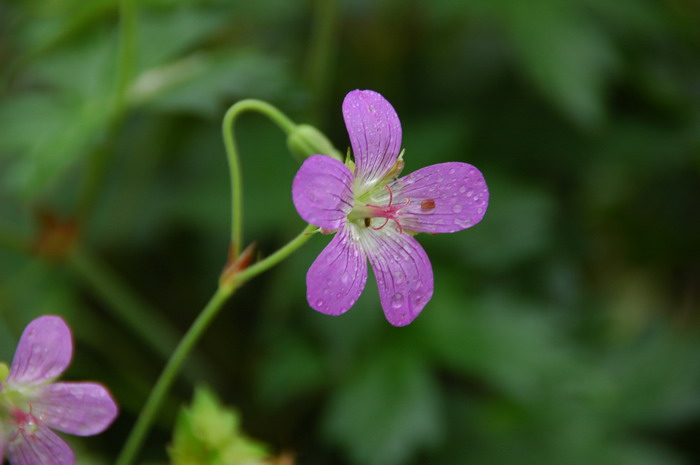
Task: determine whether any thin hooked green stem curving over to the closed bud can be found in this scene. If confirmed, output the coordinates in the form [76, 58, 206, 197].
[222, 99, 296, 258]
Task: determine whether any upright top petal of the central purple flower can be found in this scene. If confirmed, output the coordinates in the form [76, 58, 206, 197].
[343, 90, 401, 191]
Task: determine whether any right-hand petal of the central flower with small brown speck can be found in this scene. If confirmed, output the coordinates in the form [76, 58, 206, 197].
[391, 162, 489, 233]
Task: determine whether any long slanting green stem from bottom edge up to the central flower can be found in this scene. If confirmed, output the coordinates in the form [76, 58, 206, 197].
[116, 225, 316, 465]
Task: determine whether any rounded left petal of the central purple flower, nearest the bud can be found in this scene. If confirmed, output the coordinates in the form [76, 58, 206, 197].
[292, 155, 353, 229]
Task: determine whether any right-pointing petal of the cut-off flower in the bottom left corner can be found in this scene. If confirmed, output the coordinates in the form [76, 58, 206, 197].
[31, 383, 117, 436]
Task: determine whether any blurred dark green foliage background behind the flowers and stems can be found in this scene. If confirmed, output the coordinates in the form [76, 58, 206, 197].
[0, 0, 700, 465]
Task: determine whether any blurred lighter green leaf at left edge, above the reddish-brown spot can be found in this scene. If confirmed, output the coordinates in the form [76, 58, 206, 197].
[0, 32, 114, 197]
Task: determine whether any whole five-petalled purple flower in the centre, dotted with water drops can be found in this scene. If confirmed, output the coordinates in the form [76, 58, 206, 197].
[292, 90, 489, 326]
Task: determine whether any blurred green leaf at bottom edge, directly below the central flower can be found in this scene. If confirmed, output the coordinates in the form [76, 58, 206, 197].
[325, 345, 442, 465]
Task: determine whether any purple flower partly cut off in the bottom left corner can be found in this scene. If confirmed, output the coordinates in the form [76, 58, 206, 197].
[0, 316, 117, 465]
